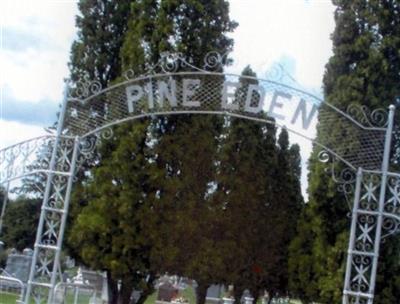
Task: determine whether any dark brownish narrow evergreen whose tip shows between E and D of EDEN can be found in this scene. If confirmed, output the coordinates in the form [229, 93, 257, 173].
[214, 67, 276, 303]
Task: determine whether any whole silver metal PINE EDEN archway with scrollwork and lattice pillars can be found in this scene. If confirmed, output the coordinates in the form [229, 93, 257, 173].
[0, 52, 400, 304]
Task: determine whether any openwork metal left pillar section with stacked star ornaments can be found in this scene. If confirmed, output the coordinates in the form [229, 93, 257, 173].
[27, 137, 78, 303]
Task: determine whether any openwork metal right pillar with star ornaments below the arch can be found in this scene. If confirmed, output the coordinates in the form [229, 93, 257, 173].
[343, 170, 400, 304]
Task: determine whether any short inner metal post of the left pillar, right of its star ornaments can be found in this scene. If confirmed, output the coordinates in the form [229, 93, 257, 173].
[47, 137, 79, 304]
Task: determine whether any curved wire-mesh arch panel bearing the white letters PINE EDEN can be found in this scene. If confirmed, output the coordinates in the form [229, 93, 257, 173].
[66, 72, 387, 169]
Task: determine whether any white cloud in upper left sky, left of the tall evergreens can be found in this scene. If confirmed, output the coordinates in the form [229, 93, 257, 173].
[0, 0, 77, 103]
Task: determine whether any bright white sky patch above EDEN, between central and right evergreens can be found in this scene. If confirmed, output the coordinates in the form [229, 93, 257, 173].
[230, 0, 334, 88]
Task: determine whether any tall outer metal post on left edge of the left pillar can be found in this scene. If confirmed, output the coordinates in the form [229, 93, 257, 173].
[25, 90, 67, 304]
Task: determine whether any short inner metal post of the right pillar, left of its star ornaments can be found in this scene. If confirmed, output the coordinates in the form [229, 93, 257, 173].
[342, 168, 362, 304]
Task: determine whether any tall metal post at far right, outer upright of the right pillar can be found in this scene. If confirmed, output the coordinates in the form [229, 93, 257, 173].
[368, 105, 395, 304]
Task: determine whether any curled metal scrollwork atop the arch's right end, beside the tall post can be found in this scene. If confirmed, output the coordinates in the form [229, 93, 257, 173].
[347, 103, 388, 128]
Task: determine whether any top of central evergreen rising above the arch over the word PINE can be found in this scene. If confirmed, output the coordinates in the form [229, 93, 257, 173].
[121, 0, 237, 73]
